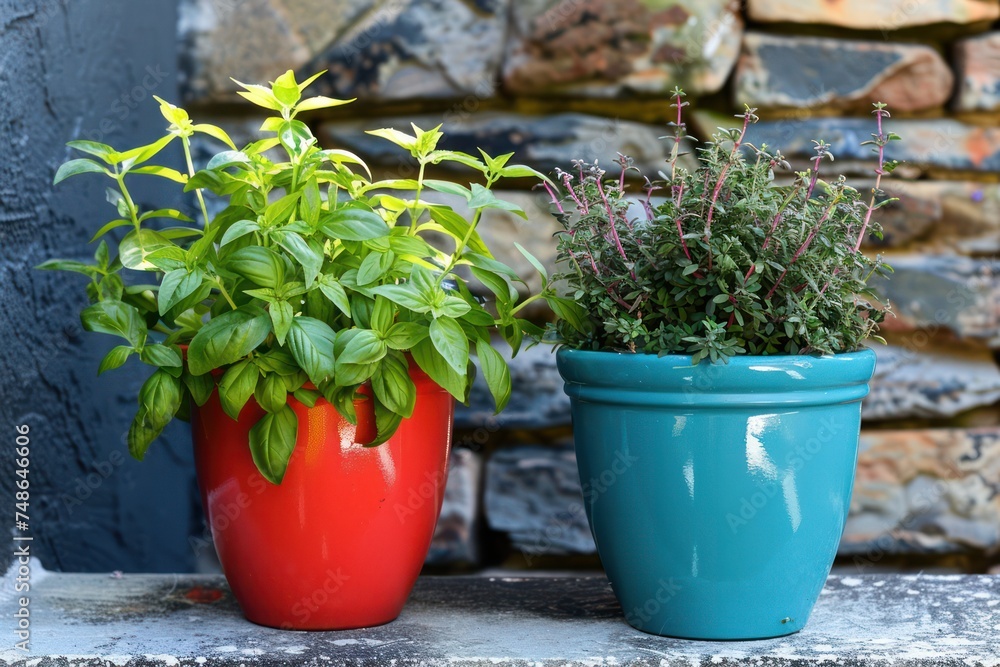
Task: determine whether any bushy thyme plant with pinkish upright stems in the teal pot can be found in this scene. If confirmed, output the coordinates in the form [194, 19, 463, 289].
[546, 89, 899, 363]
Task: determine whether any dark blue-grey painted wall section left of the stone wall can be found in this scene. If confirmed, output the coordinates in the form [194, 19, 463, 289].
[0, 0, 201, 571]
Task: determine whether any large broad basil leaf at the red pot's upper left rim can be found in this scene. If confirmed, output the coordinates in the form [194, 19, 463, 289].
[188, 305, 271, 375]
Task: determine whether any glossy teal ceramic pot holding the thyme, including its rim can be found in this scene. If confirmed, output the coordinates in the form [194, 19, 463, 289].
[558, 348, 875, 639]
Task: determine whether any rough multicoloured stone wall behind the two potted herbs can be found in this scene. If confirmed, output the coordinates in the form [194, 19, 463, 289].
[179, 0, 1000, 568]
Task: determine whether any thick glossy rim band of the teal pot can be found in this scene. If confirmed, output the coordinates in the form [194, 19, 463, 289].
[556, 347, 875, 407]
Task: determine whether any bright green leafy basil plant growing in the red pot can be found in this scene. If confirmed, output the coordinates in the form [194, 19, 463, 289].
[40, 71, 572, 484]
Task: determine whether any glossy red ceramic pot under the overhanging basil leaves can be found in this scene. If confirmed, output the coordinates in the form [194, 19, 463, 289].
[192, 365, 454, 630]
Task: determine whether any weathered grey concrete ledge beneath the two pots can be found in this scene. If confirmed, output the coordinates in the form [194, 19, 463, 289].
[0, 574, 1000, 667]
